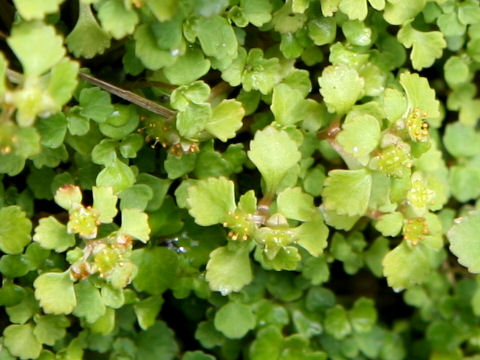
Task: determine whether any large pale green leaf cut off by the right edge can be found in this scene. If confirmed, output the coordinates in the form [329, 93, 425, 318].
[447, 212, 480, 273]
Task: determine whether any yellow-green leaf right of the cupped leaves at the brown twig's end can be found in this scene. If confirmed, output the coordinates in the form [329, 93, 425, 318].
[205, 99, 245, 142]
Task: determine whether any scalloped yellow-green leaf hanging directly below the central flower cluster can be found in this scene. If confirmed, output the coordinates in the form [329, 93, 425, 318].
[205, 246, 252, 295]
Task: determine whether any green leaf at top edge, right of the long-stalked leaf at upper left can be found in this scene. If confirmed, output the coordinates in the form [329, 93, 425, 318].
[98, 0, 138, 39]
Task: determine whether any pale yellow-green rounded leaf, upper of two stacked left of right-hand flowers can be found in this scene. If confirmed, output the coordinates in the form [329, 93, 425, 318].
[318, 63, 365, 115]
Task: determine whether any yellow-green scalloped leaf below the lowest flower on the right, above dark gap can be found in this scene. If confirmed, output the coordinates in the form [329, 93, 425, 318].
[382, 242, 430, 291]
